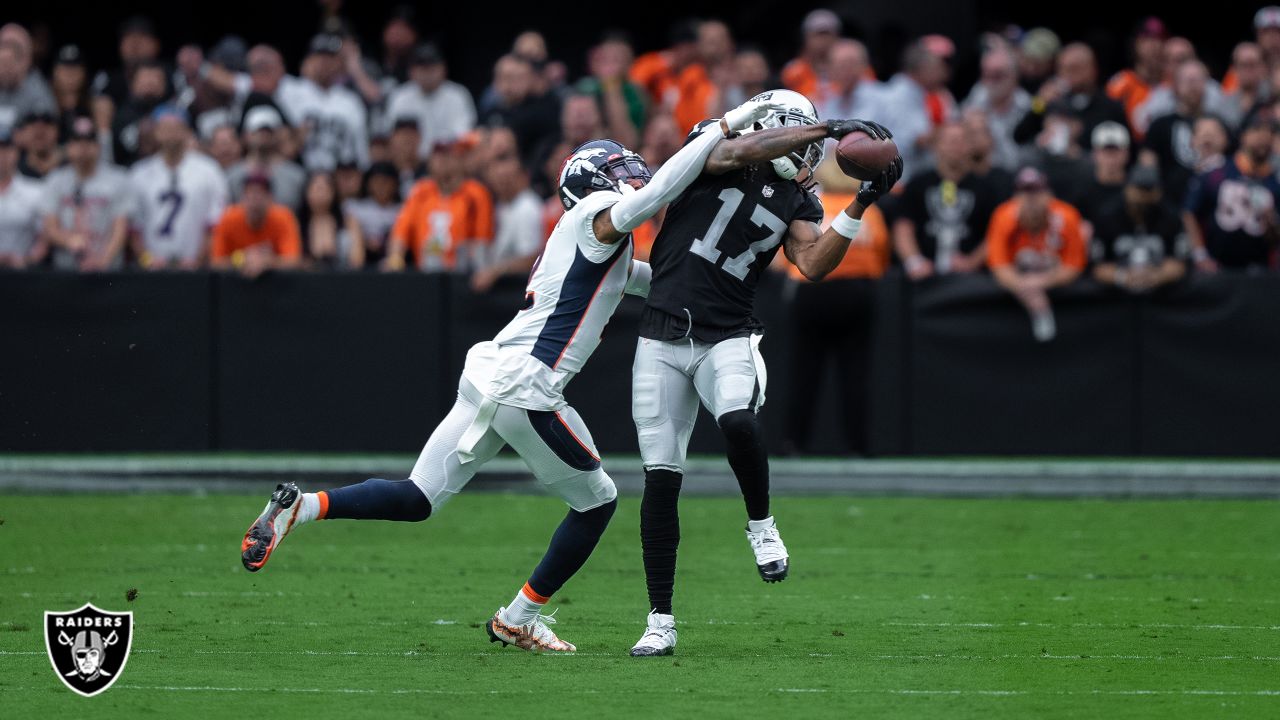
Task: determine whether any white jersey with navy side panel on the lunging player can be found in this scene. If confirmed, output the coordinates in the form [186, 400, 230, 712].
[462, 191, 632, 410]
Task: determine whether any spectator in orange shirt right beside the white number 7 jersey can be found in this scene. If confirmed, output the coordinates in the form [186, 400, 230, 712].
[210, 173, 302, 278]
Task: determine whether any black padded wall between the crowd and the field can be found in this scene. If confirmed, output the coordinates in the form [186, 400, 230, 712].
[0, 273, 1280, 456]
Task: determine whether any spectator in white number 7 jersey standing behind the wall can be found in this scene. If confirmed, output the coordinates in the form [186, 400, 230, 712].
[129, 105, 229, 270]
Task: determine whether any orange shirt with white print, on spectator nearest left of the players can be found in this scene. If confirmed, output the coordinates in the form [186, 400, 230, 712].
[392, 178, 493, 270]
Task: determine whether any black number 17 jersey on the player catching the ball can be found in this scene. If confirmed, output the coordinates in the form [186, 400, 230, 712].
[640, 157, 823, 342]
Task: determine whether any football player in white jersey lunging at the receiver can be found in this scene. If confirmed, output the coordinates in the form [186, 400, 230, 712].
[241, 94, 849, 652]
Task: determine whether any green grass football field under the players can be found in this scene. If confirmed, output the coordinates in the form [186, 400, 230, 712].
[0, 493, 1280, 720]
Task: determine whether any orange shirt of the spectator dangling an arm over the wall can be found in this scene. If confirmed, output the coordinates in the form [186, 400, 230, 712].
[987, 197, 1088, 270]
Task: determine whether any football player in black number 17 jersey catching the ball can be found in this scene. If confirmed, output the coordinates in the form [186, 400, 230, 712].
[631, 90, 902, 656]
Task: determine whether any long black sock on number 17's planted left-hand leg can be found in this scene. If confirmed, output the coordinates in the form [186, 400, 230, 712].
[640, 468, 684, 615]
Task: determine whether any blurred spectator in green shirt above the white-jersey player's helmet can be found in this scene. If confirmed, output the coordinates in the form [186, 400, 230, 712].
[575, 35, 648, 147]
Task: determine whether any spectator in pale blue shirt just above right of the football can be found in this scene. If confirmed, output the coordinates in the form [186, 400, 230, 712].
[870, 41, 950, 182]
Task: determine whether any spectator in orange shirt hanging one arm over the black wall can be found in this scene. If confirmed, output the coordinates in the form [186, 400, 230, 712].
[987, 167, 1088, 342]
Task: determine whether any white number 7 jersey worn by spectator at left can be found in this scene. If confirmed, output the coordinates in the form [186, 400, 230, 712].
[129, 151, 228, 261]
